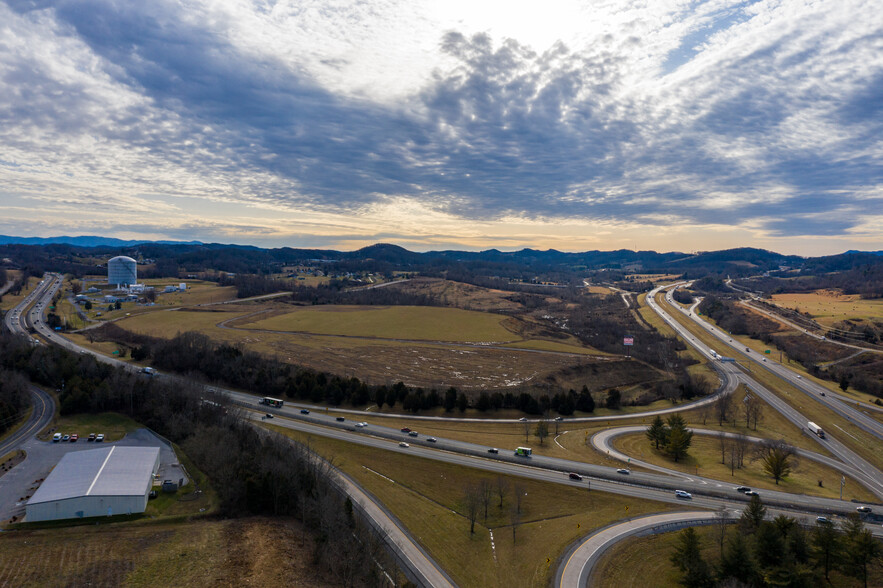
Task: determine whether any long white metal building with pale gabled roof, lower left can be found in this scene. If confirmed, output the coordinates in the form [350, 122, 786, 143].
[25, 446, 159, 522]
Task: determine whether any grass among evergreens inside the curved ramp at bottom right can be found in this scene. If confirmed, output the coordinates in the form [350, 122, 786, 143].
[589, 525, 883, 588]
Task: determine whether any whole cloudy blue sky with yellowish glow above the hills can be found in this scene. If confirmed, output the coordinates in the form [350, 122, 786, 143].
[0, 0, 883, 255]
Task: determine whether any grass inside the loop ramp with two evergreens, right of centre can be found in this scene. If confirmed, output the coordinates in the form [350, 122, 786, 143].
[613, 433, 877, 502]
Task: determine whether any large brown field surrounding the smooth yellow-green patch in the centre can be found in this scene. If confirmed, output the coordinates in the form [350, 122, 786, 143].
[112, 303, 663, 390]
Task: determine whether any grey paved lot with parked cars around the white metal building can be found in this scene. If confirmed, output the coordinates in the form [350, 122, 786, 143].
[0, 429, 187, 522]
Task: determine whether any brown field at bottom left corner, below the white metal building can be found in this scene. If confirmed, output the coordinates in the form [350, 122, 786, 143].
[0, 518, 339, 588]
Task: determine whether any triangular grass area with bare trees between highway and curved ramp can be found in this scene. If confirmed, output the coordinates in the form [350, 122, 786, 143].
[272, 427, 673, 587]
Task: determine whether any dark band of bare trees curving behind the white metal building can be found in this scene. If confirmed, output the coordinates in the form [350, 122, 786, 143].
[0, 334, 400, 586]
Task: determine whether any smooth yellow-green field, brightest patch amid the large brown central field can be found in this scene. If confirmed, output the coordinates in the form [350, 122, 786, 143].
[238, 305, 520, 343]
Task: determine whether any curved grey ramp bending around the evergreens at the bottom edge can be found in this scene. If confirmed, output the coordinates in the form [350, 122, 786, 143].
[555, 511, 735, 588]
